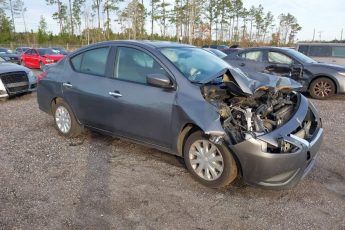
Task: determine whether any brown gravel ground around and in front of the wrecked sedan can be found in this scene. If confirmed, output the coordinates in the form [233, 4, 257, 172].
[0, 91, 345, 229]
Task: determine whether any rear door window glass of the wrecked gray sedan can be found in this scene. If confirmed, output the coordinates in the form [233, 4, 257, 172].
[71, 47, 110, 76]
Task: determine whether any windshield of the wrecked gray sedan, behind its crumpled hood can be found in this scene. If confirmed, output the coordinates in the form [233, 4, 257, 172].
[160, 47, 231, 82]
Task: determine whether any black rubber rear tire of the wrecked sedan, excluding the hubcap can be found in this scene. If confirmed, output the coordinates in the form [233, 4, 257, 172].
[53, 100, 82, 137]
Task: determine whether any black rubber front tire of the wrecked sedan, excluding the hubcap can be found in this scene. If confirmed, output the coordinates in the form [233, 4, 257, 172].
[183, 131, 238, 188]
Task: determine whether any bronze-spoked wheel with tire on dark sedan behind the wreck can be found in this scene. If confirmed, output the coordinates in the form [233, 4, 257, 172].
[309, 77, 335, 100]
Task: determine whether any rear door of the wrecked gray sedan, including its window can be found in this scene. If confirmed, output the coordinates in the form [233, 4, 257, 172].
[62, 46, 112, 129]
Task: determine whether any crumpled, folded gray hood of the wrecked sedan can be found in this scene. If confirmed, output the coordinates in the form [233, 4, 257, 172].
[200, 68, 302, 95]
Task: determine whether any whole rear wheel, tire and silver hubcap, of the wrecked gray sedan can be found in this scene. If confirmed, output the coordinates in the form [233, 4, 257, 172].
[52, 99, 83, 137]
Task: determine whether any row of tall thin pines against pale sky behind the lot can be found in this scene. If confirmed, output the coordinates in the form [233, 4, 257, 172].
[0, 0, 302, 46]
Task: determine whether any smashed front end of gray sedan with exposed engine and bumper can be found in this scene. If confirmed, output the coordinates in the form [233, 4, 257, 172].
[201, 70, 323, 188]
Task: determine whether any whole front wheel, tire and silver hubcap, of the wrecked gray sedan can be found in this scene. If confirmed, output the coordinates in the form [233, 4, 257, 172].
[183, 131, 238, 188]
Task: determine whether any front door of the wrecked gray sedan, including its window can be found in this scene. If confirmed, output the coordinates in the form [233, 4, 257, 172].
[106, 47, 176, 147]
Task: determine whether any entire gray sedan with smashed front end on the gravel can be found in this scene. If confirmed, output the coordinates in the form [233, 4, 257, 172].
[37, 41, 323, 189]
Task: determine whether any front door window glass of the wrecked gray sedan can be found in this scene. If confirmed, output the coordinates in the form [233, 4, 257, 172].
[114, 47, 166, 84]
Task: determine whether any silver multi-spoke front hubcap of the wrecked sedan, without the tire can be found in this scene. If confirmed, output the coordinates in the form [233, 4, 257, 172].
[189, 140, 224, 181]
